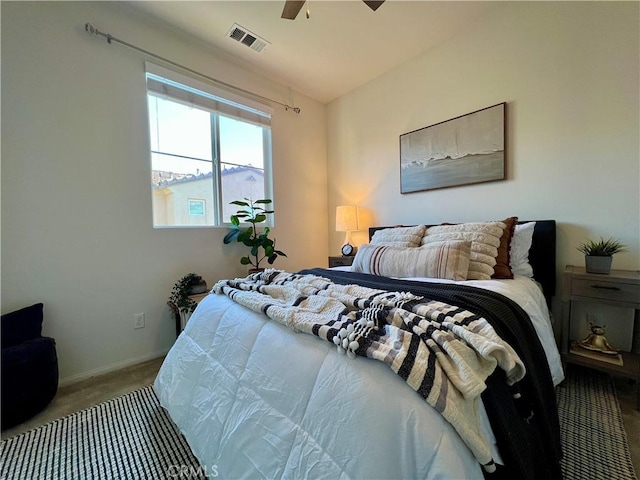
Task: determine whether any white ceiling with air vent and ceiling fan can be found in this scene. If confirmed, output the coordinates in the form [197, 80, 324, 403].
[129, 0, 500, 103]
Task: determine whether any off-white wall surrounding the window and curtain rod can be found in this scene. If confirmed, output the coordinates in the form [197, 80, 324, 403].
[1, 2, 328, 381]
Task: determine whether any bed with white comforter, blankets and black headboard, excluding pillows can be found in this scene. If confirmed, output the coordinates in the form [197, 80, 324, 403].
[154, 220, 564, 479]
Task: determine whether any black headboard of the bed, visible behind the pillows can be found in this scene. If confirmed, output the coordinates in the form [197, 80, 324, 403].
[369, 220, 556, 305]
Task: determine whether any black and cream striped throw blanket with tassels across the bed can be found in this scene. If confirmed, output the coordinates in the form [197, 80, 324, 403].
[212, 269, 525, 471]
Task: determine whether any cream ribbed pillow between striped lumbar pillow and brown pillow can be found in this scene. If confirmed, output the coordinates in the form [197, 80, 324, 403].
[422, 222, 506, 280]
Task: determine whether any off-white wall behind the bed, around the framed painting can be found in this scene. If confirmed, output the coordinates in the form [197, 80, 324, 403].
[327, 2, 640, 278]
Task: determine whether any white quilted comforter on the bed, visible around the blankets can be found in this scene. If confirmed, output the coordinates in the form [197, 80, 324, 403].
[154, 272, 562, 479]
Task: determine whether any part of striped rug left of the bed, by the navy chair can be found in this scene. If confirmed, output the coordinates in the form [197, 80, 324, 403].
[0, 386, 206, 480]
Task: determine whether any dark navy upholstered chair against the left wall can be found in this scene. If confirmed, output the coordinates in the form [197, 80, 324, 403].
[1, 303, 58, 430]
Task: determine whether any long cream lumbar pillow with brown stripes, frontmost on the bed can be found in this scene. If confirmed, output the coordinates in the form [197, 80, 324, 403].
[351, 241, 471, 280]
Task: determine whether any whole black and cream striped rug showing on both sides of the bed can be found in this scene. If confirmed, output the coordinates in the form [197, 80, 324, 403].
[0, 369, 637, 480]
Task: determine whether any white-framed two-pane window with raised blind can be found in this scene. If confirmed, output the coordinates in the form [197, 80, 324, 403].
[147, 64, 271, 227]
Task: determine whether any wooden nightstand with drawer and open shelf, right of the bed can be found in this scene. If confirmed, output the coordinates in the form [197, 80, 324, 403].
[560, 265, 640, 408]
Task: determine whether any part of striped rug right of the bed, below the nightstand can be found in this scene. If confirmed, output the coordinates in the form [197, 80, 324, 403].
[556, 365, 637, 480]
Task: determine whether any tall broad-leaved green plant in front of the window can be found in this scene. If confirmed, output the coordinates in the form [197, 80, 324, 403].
[223, 197, 287, 269]
